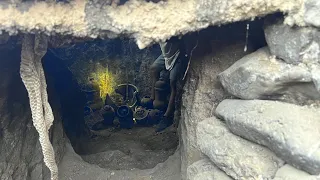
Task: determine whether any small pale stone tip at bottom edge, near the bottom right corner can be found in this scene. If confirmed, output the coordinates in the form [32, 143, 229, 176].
[273, 164, 318, 180]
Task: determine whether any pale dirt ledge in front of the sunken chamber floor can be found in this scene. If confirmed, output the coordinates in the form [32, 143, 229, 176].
[59, 144, 181, 180]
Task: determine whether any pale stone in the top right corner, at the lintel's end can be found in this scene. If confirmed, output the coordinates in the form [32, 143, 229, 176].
[304, 0, 320, 27]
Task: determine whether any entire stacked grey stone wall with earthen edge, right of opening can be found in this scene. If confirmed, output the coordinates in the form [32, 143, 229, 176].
[181, 17, 320, 180]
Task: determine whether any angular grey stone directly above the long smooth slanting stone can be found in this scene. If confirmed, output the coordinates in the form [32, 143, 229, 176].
[218, 47, 320, 104]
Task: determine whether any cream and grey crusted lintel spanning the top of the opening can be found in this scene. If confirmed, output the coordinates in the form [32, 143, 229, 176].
[0, 0, 303, 48]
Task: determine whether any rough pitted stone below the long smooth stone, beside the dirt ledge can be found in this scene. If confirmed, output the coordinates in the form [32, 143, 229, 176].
[197, 117, 284, 179]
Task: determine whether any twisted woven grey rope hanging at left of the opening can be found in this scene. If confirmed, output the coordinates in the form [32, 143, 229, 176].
[20, 35, 58, 180]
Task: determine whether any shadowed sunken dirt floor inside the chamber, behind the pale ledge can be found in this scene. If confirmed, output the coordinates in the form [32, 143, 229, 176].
[79, 127, 179, 170]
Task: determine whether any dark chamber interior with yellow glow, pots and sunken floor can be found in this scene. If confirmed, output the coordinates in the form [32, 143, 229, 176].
[43, 38, 179, 170]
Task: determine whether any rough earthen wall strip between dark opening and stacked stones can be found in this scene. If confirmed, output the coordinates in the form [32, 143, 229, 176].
[179, 25, 256, 179]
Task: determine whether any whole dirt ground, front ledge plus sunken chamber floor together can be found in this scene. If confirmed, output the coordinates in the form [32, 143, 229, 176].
[59, 118, 181, 180]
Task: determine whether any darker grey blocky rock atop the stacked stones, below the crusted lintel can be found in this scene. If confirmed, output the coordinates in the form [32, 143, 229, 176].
[264, 19, 320, 64]
